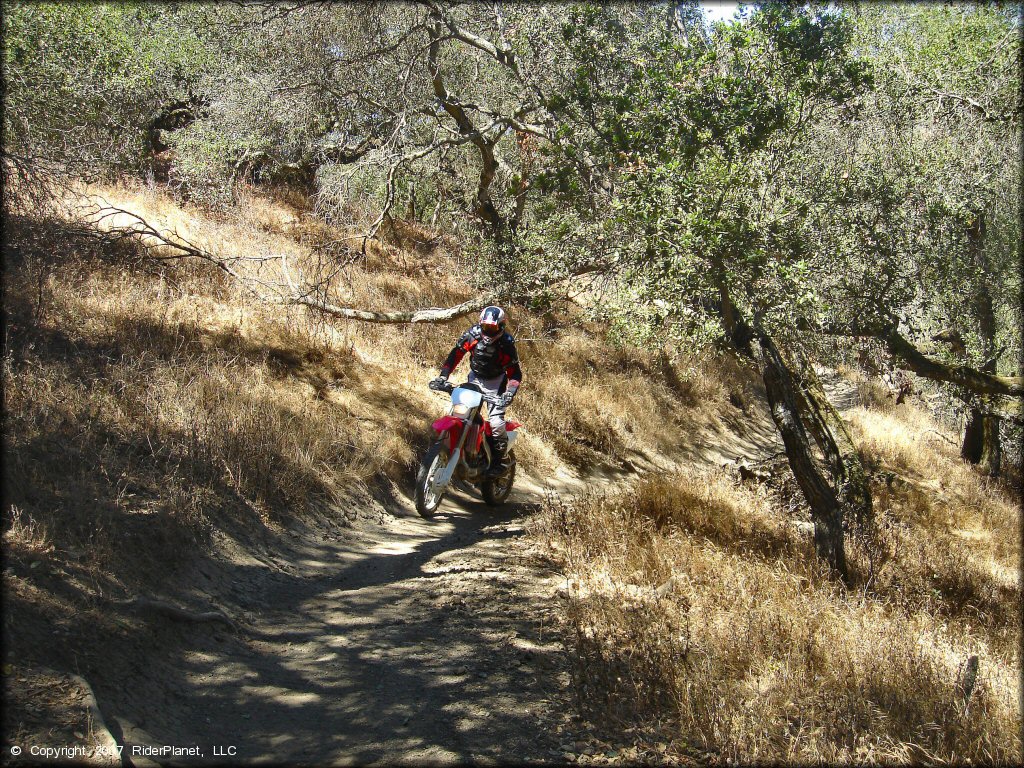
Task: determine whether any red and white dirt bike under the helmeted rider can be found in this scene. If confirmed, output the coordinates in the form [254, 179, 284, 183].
[416, 382, 520, 518]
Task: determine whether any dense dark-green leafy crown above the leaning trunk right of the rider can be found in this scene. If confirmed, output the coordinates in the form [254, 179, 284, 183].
[528, 6, 870, 346]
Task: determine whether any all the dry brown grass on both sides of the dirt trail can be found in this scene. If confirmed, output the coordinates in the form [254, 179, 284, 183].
[3, 179, 1021, 762]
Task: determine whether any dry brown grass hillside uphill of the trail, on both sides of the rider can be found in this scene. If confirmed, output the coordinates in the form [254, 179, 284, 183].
[3, 179, 749, 653]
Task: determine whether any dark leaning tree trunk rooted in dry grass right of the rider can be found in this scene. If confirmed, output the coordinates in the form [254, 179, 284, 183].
[758, 331, 851, 583]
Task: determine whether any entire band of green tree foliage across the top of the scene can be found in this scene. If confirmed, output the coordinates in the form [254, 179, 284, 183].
[4, 3, 1021, 382]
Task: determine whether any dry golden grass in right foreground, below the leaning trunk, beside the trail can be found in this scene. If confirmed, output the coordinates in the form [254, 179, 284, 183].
[534, 450, 1022, 764]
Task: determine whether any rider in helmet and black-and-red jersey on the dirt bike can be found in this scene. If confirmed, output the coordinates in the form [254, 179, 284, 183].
[430, 306, 522, 477]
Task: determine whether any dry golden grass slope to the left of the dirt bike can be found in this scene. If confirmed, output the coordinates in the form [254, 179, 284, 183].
[4, 188, 446, 589]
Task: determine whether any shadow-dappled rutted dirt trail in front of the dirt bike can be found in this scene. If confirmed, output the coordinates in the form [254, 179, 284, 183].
[100, 483, 585, 765]
